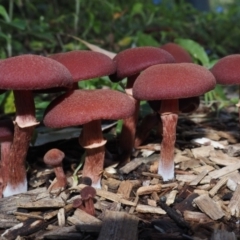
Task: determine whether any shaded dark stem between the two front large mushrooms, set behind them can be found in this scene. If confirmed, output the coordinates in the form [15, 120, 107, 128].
[119, 74, 140, 162]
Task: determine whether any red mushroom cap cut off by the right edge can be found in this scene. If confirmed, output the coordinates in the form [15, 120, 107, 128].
[211, 54, 240, 84]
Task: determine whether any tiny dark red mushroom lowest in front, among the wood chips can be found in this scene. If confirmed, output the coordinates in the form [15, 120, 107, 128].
[80, 186, 96, 216]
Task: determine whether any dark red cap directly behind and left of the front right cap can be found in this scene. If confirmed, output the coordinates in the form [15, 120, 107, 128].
[110, 47, 175, 81]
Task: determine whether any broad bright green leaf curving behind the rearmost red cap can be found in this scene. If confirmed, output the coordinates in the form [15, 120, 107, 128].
[174, 38, 209, 67]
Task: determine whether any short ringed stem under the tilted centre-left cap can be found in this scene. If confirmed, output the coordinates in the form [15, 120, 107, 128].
[79, 120, 106, 188]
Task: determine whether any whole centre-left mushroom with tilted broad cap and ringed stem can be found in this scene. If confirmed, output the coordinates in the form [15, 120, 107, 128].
[43, 89, 134, 188]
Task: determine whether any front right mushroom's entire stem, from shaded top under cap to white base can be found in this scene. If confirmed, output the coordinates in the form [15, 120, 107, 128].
[158, 99, 178, 181]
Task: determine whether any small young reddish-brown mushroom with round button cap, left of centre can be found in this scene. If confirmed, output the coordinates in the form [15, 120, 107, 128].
[43, 148, 67, 191]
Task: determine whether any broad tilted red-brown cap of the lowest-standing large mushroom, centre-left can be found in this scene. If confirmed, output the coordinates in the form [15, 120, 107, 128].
[43, 89, 134, 128]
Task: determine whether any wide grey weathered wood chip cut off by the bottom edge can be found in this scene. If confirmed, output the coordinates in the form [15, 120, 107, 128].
[98, 210, 139, 240]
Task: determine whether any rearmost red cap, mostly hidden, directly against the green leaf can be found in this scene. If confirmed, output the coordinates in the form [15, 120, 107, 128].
[160, 43, 193, 63]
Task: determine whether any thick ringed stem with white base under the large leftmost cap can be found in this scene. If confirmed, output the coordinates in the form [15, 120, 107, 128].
[3, 91, 38, 197]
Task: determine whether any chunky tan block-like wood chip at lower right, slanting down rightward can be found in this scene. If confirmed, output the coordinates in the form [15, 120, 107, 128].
[193, 195, 224, 220]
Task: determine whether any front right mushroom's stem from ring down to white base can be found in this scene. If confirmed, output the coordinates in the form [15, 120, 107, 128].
[158, 113, 178, 181]
